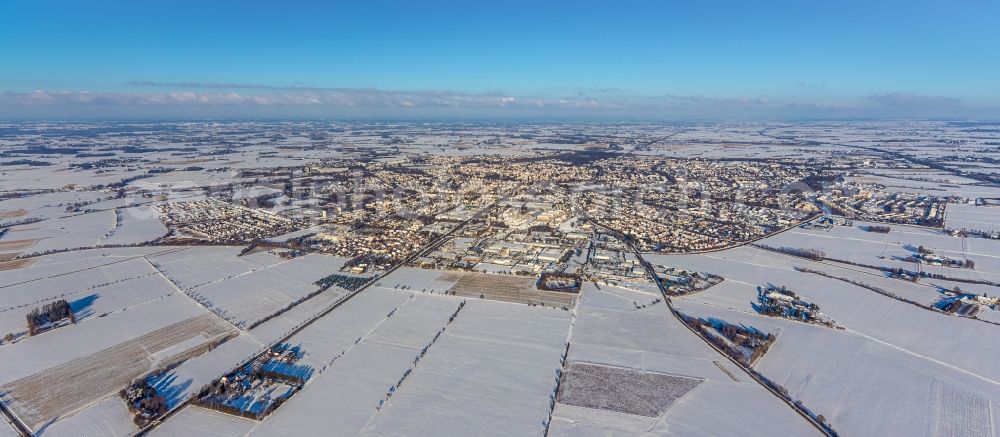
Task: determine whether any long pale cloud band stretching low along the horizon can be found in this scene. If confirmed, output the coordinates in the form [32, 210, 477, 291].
[0, 81, 988, 117]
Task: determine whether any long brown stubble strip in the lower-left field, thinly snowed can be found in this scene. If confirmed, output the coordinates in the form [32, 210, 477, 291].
[0, 314, 235, 430]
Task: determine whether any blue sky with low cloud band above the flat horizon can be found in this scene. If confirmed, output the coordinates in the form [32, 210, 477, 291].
[0, 0, 1000, 119]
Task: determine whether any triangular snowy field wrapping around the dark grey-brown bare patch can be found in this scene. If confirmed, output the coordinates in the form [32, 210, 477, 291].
[550, 284, 816, 436]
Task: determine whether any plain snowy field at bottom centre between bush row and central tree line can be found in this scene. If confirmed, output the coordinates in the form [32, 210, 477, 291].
[362, 299, 571, 436]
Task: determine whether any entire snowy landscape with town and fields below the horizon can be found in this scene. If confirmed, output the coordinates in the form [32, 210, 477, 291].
[0, 121, 1000, 437]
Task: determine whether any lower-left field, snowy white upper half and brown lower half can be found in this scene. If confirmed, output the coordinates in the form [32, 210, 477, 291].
[0, 294, 235, 428]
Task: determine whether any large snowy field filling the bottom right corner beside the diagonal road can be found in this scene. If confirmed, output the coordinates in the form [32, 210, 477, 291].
[678, 301, 1000, 435]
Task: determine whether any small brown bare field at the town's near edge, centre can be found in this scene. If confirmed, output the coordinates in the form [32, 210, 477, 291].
[448, 273, 576, 308]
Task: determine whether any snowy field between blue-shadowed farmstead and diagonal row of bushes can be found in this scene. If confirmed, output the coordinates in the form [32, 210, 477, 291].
[254, 290, 462, 436]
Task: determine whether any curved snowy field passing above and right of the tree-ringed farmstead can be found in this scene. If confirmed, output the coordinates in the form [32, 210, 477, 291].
[650, 247, 1000, 381]
